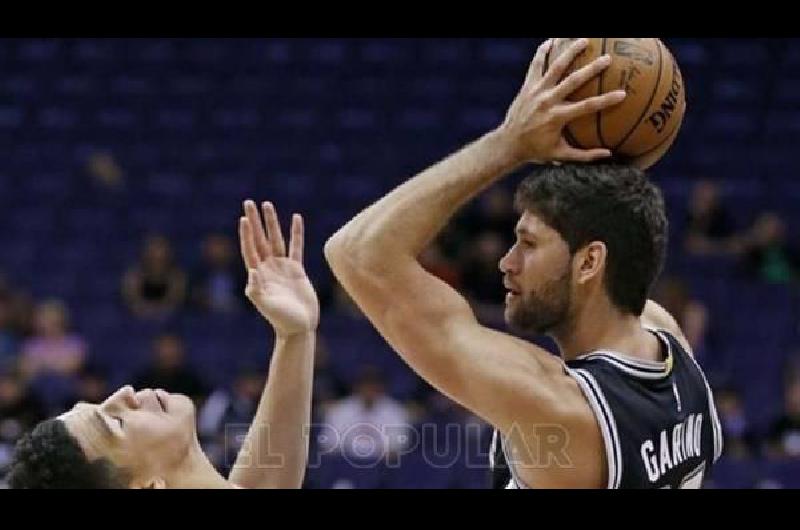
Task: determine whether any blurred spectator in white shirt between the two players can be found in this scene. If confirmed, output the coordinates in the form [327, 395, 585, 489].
[320, 367, 410, 458]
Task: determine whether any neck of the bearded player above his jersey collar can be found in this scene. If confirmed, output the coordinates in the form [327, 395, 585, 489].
[553, 294, 658, 361]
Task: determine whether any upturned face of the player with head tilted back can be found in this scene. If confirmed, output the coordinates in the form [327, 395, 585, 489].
[61, 386, 197, 485]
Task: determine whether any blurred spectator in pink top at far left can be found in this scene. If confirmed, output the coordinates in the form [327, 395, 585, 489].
[20, 300, 86, 380]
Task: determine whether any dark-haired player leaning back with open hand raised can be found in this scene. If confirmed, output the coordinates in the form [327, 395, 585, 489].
[9, 201, 319, 488]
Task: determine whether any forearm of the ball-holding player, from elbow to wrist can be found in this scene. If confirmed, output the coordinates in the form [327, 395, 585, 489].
[326, 130, 521, 268]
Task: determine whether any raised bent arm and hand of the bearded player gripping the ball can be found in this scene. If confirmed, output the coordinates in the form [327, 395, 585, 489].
[325, 41, 624, 440]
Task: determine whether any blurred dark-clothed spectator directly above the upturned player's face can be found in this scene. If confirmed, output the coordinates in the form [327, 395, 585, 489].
[133, 334, 208, 404]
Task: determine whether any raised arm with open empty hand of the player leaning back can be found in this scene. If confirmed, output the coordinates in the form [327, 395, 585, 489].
[229, 201, 319, 488]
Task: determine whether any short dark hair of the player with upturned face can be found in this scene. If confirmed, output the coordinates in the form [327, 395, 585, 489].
[8, 418, 130, 489]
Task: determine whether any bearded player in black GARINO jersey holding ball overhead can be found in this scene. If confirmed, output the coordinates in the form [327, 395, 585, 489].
[325, 40, 721, 488]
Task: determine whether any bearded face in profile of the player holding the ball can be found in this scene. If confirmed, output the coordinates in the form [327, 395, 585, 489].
[500, 212, 572, 334]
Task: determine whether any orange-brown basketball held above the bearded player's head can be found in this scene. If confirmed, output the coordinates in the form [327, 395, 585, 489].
[544, 38, 686, 169]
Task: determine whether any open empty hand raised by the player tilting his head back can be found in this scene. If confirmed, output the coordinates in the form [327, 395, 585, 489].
[239, 200, 319, 337]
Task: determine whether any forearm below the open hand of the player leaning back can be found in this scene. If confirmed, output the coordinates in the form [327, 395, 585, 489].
[230, 331, 316, 488]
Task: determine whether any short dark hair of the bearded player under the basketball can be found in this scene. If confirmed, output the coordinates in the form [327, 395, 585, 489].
[514, 163, 667, 316]
